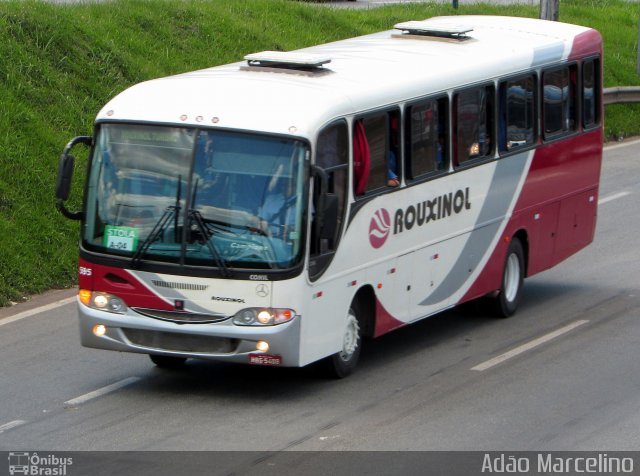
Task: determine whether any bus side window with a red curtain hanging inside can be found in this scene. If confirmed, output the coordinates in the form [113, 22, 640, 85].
[353, 110, 401, 196]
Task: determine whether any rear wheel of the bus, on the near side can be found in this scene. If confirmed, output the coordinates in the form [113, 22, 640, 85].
[494, 238, 525, 318]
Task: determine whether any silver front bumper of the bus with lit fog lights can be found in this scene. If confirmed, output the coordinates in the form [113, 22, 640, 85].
[78, 303, 300, 367]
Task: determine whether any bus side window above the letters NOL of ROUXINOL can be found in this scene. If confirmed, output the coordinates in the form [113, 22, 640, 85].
[453, 86, 494, 167]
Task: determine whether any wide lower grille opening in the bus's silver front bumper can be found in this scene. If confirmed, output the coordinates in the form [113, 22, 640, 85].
[122, 328, 240, 354]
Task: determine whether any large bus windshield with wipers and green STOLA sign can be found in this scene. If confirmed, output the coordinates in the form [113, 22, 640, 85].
[83, 124, 307, 274]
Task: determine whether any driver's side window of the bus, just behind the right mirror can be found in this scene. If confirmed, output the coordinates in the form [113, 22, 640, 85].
[311, 121, 349, 260]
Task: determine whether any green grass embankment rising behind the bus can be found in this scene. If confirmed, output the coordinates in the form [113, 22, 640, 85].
[0, 0, 640, 305]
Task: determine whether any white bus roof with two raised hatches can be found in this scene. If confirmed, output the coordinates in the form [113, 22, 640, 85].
[97, 16, 601, 139]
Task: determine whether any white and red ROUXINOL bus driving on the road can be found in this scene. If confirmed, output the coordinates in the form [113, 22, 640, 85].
[56, 16, 603, 376]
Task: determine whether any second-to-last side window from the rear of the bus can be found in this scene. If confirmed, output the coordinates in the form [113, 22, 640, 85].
[542, 66, 576, 139]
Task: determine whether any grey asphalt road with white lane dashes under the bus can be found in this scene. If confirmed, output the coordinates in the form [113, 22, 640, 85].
[0, 141, 640, 471]
